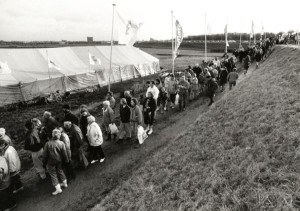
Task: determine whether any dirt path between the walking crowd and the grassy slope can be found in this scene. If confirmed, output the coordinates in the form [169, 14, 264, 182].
[12, 61, 258, 211]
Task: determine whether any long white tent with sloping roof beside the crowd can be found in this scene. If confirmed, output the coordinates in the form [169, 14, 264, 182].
[0, 46, 160, 107]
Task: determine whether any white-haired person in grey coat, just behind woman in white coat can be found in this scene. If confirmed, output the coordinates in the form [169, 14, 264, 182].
[102, 98, 116, 141]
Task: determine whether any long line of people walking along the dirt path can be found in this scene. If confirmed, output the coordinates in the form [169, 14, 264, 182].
[0, 38, 276, 210]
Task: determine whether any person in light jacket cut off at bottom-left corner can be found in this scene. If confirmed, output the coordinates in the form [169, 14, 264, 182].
[0, 155, 17, 210]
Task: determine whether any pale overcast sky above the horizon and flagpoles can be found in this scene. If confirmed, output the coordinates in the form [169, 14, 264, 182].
[0, 0, 300, 41]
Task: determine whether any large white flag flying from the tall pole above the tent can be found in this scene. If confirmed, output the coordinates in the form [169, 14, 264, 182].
[117, 12, 142, 46]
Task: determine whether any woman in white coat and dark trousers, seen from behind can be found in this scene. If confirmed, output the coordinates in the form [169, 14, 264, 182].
[86, 116, 105, 163]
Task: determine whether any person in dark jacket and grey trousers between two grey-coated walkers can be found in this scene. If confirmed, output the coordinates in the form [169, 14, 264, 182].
[119, 98, 131, 142]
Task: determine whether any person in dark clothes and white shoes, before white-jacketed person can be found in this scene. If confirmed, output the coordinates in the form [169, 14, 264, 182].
[143, 91, 156, 135]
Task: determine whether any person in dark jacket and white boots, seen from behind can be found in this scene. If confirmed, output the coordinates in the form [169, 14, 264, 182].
[43, 129, 69, 196]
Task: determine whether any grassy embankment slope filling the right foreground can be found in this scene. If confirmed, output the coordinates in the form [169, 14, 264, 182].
[93, 46, 300, 210]
